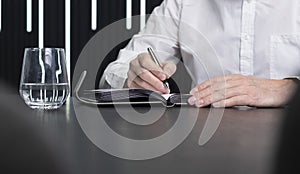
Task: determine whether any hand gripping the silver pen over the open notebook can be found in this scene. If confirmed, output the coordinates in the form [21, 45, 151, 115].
[126, 53, 176, 93]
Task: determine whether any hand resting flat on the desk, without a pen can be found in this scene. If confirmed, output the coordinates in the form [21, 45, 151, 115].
[188, 75, 297, 107]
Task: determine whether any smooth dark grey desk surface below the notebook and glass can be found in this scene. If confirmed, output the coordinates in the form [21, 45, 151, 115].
[27, 98, 284, 174]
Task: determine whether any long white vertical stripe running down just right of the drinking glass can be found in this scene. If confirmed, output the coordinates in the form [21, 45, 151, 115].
[65, 0, 71, 84]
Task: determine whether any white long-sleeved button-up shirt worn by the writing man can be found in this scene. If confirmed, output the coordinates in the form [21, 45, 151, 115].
[103, 0, 300, 88]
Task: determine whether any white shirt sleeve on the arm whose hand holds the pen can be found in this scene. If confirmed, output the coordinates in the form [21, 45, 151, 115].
[100, 0, 181, 88]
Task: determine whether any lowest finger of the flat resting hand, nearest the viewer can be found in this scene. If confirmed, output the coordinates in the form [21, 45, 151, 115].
[212, 95, 252, 108]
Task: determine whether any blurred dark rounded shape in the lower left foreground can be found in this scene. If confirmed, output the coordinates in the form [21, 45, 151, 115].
[0, 86, 72, 174]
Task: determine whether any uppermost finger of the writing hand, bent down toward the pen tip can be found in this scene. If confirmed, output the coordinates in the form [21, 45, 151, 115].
[138, 53, 167, 81]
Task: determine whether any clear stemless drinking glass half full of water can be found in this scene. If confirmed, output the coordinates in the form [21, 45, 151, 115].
[19, 48, 70, 109]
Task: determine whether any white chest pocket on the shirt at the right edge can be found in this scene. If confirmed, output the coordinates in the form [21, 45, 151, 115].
[270, 35, 300, 79]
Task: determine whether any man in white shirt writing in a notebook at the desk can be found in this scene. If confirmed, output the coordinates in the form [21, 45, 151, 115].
[104, 0, 300, 107]
